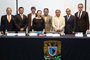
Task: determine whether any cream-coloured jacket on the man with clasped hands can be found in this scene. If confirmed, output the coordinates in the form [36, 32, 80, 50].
[52, 16, 65, 33]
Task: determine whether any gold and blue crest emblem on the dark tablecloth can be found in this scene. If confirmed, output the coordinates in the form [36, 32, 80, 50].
[44, 40, 61, 60]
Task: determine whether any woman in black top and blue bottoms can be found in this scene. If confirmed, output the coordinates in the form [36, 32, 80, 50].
[32, 10, 45, 34]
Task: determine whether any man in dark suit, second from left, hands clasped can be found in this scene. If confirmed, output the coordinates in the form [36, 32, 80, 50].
[14, 7, 28, 31]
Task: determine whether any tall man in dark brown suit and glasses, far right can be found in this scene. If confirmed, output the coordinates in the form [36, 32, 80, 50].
[75, 3, 89, 34]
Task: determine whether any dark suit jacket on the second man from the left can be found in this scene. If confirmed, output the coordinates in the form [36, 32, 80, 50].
[14, 14, 28, 31]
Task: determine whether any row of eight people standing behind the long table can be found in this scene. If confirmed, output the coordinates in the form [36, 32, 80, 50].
[1, 3, 89, 34]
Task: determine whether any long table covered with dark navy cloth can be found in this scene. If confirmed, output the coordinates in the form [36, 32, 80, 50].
[0, 35, 90, 60]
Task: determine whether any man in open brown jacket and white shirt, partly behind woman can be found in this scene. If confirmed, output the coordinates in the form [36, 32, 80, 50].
[28, 7, 36, 31]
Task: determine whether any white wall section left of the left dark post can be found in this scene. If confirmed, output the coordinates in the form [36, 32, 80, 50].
[0, 0, 16, 25]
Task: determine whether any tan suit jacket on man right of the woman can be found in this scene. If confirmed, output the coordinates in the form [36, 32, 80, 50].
[42, 15, 52, 32]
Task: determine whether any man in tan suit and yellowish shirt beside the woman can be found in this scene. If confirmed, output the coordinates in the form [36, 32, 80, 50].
[42, 8, 52, 32]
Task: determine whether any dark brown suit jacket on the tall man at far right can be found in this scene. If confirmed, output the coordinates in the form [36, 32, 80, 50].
[75, 11, 89, 32]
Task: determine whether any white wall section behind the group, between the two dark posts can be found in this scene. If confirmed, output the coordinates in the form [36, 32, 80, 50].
[18, 0, 85, 16]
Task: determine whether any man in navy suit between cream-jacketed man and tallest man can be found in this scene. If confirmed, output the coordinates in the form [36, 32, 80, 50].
[64, 8, 76, 34]
